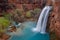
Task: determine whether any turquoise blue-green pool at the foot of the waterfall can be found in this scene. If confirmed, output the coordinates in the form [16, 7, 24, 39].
[10, 22, 49, 40]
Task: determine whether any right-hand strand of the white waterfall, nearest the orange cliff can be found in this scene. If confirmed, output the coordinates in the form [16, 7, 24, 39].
[40, 6, 52, 33]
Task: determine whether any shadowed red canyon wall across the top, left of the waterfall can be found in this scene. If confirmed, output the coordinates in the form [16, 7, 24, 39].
[0, 0, 45, 12]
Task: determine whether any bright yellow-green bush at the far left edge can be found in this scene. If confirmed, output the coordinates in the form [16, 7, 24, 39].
[0, 17, 10, 32]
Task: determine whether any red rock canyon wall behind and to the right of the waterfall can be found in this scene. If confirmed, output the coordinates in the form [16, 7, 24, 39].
[8, 0, 60, 38]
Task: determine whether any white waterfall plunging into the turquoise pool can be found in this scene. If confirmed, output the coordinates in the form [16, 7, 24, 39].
[32, 6, 52, 34]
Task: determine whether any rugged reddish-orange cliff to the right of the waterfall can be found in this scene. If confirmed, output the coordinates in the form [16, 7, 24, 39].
[47, 0, 60, 40]
